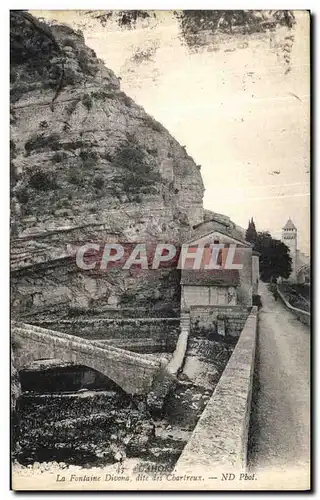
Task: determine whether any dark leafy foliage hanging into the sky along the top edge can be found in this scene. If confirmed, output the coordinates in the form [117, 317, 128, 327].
[90, 9, 296, 73]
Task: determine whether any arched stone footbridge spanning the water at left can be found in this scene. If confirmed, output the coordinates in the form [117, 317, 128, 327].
[11, 321, 160, 394]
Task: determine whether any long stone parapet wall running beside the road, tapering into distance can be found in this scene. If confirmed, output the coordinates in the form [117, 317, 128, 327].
[175, 307, 257, 476]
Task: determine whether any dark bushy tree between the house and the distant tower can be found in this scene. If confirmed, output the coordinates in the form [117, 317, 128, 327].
[254, 232, 292, 281]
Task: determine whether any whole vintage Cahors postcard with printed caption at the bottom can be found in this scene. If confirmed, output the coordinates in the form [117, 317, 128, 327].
[10, 10, 311, 491]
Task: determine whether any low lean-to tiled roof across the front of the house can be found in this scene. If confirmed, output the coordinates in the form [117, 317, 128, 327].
[181, 269, 240, 287]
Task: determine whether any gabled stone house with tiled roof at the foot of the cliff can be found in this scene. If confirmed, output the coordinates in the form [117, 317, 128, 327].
[181, 211, 259, 309]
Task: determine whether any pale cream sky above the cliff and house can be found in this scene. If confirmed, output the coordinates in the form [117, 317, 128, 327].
[34, 11, 310, 253]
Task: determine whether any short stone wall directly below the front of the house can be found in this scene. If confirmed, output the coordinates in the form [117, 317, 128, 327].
[190, 306, 250, 337]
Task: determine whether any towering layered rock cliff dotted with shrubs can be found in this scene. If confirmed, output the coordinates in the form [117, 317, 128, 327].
[10, 11, 204, 320]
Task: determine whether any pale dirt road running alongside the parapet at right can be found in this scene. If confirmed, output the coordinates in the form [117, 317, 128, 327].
[250, 283, 310, 475]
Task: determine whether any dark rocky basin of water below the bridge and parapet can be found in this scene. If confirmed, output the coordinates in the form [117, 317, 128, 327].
[14, 338, 234, 473]
